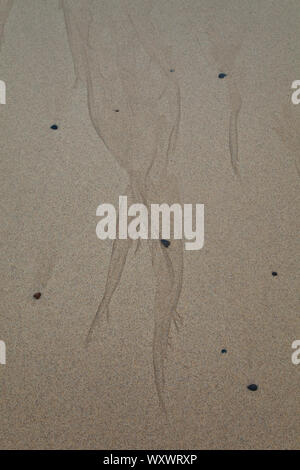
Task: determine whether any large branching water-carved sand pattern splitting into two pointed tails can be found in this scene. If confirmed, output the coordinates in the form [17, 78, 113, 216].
[61, 0, 183, 413]
